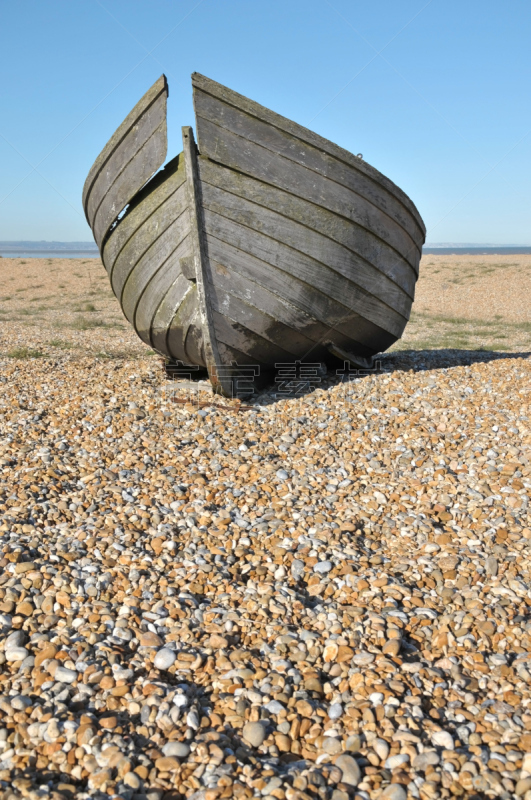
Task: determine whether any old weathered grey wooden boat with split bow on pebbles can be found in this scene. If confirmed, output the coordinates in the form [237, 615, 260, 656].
[83, 73, 425, 396]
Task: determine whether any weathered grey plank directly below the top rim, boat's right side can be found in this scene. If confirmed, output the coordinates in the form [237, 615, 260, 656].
[194, 90, 425, 246]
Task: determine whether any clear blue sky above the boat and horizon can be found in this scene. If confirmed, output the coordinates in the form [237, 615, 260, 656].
[0, 0, 531, 244]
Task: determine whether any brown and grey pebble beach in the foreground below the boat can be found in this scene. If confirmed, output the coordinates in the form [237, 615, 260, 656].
[0, 256, 531, 800]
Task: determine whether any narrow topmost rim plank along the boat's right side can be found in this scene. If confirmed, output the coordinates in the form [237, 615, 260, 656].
[192, 72, 425, 231]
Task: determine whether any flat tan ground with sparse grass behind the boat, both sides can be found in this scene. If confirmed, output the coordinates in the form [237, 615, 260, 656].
[0, 255, 531, 358]
